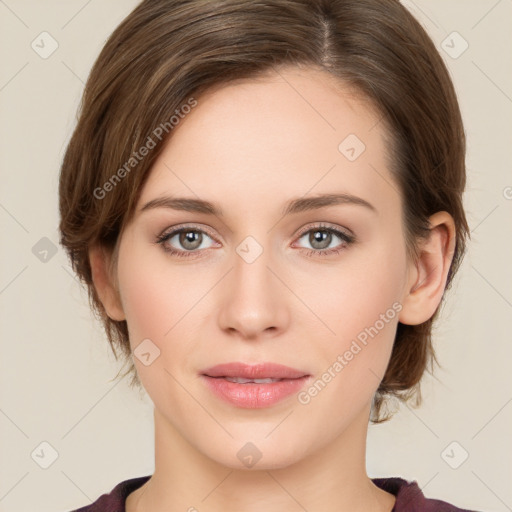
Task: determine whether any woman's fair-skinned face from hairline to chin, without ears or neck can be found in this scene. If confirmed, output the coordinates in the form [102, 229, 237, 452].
[117, 68, 410, 468]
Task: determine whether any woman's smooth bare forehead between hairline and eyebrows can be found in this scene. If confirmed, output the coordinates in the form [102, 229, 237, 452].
[139, 68, 397, 216]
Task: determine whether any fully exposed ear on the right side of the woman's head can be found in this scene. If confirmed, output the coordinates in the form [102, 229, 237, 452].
[398, 212, 455, 325]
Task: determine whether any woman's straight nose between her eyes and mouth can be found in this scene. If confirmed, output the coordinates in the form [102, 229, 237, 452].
[218, 241, 290, 339]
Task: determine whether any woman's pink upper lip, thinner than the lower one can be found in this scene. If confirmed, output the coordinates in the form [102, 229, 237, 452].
[201, 362, 309, 379]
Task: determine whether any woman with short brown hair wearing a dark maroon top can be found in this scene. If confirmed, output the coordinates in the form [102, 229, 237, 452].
[60, 0, 480, 512]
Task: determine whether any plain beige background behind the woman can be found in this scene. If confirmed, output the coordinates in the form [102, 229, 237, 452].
[0, 0, 512, 512]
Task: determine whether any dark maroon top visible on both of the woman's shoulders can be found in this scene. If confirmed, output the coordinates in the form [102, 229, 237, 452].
[72, 475, 482, 512]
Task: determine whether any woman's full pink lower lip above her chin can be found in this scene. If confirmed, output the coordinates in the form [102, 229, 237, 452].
[201, 375, 310, 409]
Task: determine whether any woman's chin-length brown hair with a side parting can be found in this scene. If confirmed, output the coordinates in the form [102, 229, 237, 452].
[59, 0, 469, 423]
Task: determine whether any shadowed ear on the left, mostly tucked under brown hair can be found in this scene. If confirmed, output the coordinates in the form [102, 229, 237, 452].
[89, 245, 126, 322]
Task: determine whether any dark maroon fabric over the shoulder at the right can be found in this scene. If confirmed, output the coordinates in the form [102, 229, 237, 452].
[372, 477, 484, 512]
